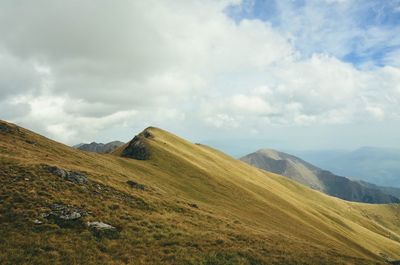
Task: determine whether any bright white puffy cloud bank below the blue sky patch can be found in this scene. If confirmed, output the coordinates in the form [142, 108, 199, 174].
[203, 52, 400, 128]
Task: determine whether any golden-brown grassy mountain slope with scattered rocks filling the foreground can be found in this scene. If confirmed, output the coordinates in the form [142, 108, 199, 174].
[0, 122, 400, 264]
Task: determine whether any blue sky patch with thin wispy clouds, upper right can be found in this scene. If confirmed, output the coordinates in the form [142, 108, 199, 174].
[226, 0, 400, 66]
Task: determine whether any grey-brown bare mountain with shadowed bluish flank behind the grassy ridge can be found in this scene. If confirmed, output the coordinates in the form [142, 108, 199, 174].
[240, 149, 400, 203]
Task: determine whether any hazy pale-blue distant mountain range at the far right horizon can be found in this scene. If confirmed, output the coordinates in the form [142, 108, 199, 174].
[296, 147, 400, 188]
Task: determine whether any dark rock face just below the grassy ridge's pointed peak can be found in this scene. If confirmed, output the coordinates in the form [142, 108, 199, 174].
[122, 130, 154, 160]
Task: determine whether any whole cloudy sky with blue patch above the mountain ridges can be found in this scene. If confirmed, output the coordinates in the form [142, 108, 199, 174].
[0, 0, 400, 155]
